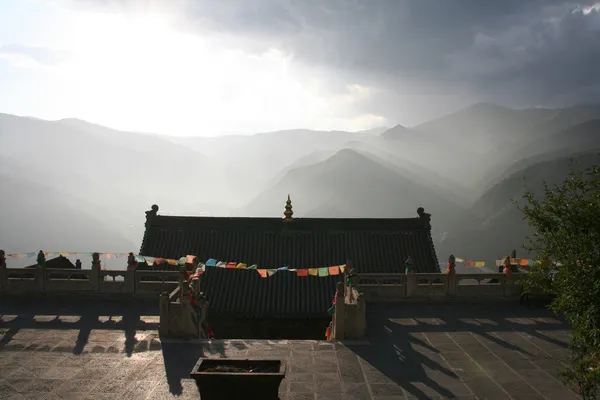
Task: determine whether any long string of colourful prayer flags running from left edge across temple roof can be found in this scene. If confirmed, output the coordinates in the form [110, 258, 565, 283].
[6, 251, 346, 278]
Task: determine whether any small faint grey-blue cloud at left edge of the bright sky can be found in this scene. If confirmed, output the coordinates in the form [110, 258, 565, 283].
[0, 43, 70, 67]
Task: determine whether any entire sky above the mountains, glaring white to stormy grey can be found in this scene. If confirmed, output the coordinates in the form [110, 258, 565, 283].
[0, 0, 600, 136]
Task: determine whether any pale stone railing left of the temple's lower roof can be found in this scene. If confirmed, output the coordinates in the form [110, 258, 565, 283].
[0, 265, 180, 297]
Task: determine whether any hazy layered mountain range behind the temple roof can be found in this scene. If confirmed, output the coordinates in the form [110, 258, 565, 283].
[0, 104, 600, 268]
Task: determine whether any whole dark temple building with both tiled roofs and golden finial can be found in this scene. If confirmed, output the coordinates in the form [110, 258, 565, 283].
[140, 196, 440, 339]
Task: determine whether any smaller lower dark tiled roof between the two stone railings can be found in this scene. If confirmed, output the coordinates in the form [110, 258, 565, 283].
[201, 267, 339, 318]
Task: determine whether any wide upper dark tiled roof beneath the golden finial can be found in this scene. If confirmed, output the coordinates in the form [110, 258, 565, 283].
[140, 216, 439, 273]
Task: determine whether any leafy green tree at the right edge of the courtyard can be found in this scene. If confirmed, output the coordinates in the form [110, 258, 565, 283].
[517, 163, 600, 399]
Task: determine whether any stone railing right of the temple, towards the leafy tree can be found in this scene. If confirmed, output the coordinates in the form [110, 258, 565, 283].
[355, 273, 523, 303]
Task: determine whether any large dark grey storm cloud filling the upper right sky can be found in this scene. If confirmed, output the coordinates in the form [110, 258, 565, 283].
[32, 0, 600, 122]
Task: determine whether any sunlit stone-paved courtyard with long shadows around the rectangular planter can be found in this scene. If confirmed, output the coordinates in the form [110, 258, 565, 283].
[0, 299, 576, 400]
